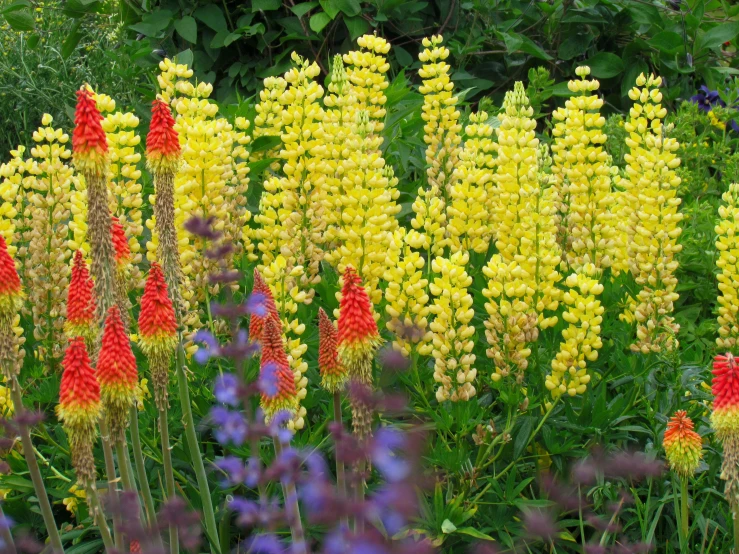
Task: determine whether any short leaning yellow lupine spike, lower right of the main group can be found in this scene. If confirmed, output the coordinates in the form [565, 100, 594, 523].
[544, 270, 605, 399]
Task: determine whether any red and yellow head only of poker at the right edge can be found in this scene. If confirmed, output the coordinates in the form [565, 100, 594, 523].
[711, 354, 739, 440]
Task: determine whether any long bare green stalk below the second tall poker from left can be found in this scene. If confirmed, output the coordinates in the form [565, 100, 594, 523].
[176, 338, 220, 553]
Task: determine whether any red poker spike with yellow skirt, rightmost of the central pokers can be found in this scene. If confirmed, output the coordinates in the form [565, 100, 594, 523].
[338, 266, 382, 438]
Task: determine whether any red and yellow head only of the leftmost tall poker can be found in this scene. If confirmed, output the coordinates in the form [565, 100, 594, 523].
[72, 87, 108, 175]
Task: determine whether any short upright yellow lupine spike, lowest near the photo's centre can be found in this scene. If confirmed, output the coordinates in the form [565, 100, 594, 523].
[429, 252, 477, 402]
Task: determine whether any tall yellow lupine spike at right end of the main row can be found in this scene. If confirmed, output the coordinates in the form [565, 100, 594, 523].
[620, 74, 682, 354]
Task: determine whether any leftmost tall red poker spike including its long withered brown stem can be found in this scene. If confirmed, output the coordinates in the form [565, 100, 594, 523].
[72, 87, 116, 321]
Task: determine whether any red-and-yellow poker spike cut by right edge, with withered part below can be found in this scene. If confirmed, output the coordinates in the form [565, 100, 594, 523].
[711, 354, 739, 500]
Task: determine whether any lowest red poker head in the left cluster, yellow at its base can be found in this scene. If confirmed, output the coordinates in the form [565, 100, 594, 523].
[57, 337, 102, 426]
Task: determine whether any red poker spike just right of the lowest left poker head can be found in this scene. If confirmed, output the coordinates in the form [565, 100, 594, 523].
[97, 306, 138, 442]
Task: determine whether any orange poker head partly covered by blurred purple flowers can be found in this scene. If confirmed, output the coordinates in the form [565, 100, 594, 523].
[260, 317, 298, 421]
